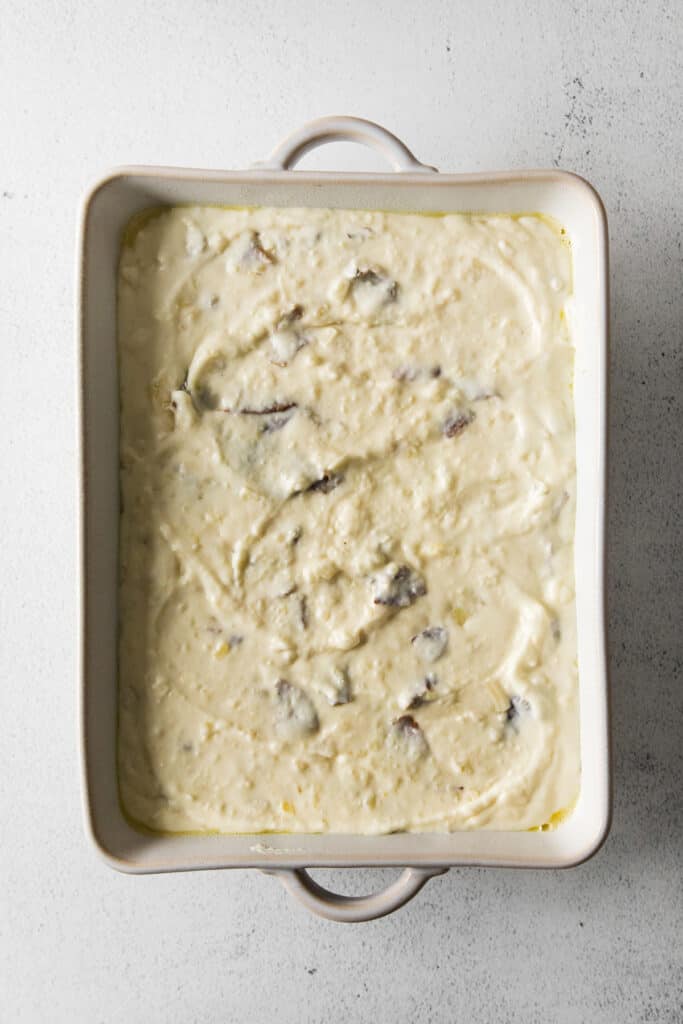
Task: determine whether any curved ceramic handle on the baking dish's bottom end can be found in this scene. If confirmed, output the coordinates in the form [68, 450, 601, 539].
[262, 867, 449, 924]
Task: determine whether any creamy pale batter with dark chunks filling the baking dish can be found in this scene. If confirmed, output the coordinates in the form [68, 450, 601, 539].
[119, 207, 580, 834]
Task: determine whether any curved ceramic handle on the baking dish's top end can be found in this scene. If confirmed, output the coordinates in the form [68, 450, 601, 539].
[255, 117, 436, 174]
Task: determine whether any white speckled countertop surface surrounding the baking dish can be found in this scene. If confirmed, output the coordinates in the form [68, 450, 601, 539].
[0, 0, 683, 1024]
